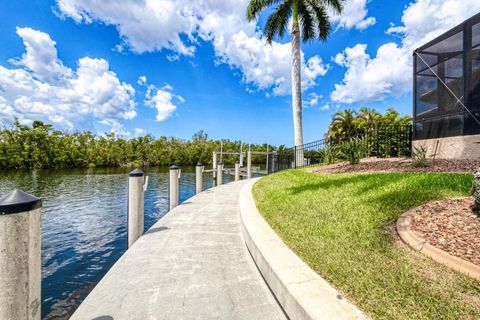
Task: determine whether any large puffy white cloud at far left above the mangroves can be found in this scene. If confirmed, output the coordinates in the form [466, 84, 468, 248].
[0, 28, 136, 129]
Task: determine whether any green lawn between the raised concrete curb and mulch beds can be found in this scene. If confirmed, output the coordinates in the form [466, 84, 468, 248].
[253, 170, 480, 319]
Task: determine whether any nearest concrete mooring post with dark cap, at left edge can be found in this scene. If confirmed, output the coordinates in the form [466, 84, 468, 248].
[0, 189, 42, 320]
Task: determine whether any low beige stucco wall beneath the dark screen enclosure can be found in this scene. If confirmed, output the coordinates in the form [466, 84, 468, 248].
[413, 134, 480, 159]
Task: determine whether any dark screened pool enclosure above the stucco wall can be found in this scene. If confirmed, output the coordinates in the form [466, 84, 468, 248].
[413, 14, 480, 140]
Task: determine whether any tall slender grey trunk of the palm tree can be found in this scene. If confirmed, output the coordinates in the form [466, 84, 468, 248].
[292, 1, 303, 166]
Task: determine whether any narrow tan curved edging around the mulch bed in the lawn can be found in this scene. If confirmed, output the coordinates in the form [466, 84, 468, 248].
[397, 206, 480, 281]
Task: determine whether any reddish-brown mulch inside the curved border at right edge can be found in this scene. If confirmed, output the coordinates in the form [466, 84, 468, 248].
[411, 197, 480, 266]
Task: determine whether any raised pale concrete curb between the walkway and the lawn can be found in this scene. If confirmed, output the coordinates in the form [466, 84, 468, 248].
[240, 179, 369, 320]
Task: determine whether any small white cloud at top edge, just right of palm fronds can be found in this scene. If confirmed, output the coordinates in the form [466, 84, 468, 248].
[330, 0, 377, 30]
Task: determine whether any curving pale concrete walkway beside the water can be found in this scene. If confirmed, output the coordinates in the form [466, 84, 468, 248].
[71, 181, 286, 320]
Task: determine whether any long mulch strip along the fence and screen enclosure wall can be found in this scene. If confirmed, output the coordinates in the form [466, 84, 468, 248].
[312, 158, 480, 173]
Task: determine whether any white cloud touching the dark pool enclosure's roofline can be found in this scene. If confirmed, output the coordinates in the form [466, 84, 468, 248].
[331, 0, 480, 103]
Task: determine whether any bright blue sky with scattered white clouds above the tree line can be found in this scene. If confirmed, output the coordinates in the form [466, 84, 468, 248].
[0, 0, 480, 145]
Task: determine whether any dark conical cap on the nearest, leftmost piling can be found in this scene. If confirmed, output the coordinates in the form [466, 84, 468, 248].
[0, 189, 42, 215]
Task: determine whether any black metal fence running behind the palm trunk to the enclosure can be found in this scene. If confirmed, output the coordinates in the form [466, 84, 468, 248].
[274, 125, 412, 171]
